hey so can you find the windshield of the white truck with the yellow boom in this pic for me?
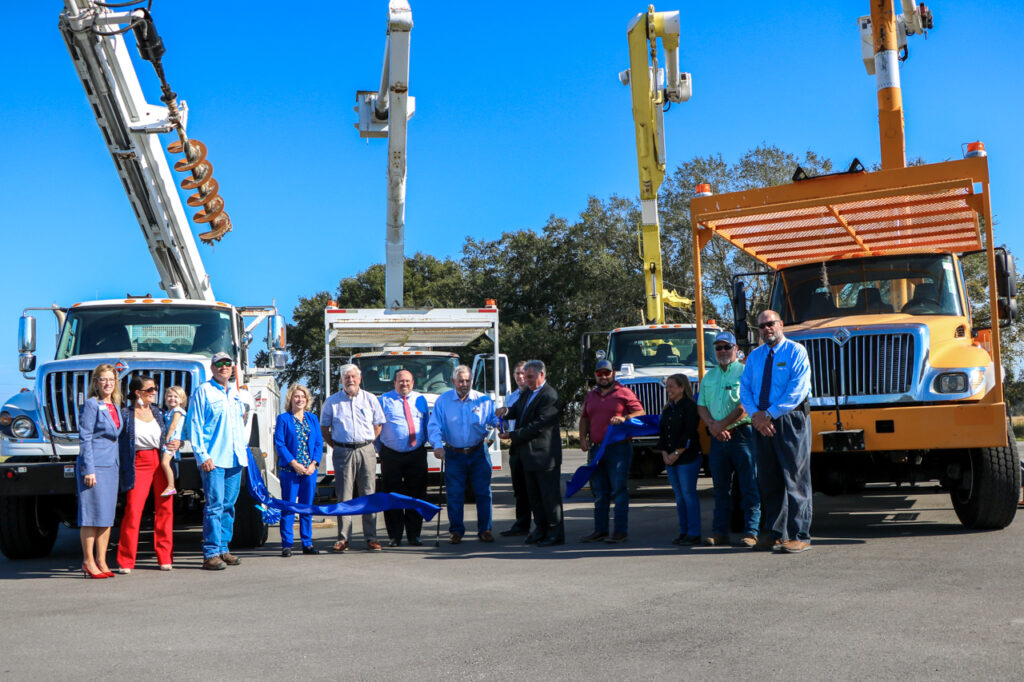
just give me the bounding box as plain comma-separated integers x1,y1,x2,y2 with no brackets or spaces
608,328,718,372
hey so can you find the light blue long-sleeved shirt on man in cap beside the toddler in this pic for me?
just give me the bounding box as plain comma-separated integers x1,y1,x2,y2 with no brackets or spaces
185,379,249,469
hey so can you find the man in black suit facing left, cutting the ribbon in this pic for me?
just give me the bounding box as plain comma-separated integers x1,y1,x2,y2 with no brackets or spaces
497,360,565,547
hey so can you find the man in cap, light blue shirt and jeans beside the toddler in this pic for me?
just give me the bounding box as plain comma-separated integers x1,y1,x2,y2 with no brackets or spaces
185,352,249,570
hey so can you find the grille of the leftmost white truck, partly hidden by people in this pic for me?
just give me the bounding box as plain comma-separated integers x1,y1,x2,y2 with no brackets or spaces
43,369,193,435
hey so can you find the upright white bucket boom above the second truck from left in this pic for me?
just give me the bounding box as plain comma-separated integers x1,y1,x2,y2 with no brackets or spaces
355,0,416,308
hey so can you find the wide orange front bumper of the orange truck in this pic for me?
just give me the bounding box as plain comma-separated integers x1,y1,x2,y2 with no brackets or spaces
811,402,1007,453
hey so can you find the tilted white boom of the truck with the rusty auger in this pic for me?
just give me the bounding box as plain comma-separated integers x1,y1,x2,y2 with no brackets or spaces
59,0,215,301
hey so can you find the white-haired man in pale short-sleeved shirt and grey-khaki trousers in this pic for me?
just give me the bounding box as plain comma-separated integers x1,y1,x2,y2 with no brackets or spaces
321,365,384,552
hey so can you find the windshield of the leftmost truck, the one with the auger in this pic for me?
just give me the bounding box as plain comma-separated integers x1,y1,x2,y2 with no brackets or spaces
56,305,233,359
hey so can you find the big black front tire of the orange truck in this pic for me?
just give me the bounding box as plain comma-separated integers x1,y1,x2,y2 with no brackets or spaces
949,421,1021,530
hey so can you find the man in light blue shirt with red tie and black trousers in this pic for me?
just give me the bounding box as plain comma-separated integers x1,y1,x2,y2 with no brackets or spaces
380,370,430,547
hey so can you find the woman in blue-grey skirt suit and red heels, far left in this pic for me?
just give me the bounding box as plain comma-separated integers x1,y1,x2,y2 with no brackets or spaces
75,365,124,578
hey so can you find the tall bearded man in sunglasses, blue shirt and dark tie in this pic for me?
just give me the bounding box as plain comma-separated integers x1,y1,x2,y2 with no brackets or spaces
739,310,812,553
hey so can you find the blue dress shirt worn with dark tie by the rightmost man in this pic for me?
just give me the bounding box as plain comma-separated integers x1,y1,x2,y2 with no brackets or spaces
739,337,811,419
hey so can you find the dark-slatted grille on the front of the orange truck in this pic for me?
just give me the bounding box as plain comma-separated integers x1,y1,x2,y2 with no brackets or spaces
794,334,913,397
